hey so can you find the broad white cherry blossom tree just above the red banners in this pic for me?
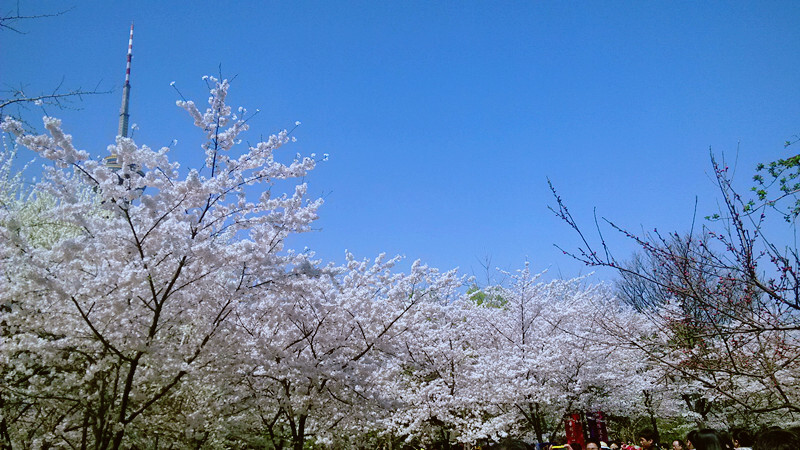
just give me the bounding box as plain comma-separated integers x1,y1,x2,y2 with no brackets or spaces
388,265,649,444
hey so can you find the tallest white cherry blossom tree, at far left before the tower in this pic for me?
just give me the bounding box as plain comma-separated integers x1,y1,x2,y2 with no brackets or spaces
0,78,321,448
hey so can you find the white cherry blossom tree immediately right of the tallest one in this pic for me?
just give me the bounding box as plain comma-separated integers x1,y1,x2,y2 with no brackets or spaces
231,255,460,450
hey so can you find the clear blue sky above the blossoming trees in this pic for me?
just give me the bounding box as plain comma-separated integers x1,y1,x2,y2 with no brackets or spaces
0,1,800,278
